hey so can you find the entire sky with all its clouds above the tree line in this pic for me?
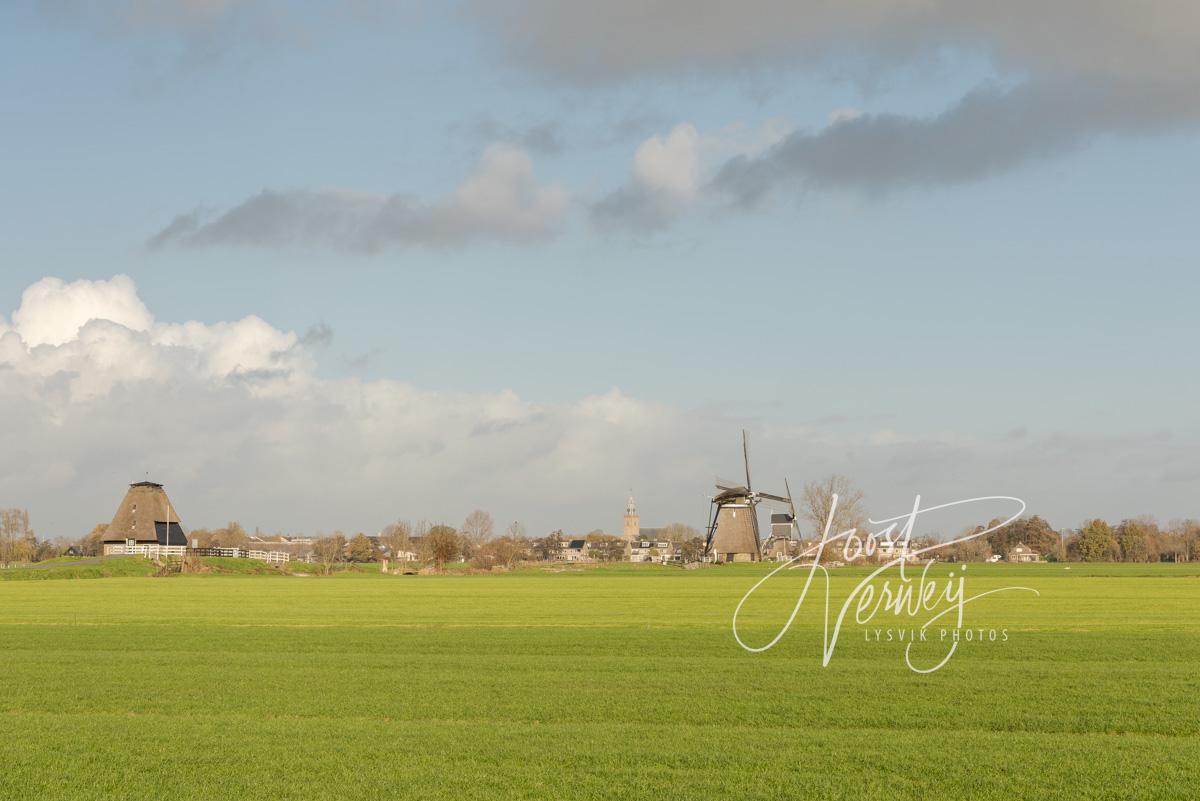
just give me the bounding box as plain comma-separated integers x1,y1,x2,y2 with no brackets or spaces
0,0,1200,537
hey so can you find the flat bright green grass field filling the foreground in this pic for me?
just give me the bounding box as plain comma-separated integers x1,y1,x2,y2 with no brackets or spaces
0,565,1200,801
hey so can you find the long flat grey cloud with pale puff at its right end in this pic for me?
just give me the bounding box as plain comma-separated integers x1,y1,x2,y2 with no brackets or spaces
149,144,570,252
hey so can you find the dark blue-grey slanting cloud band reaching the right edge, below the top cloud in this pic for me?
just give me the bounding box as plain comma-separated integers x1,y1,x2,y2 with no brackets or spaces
710,82,1200,204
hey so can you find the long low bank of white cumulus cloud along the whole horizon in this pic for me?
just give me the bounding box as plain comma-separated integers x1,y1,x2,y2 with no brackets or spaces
0,277,1200,536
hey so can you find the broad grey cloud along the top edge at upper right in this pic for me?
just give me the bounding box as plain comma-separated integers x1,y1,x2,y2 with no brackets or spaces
468,0,1200,88
